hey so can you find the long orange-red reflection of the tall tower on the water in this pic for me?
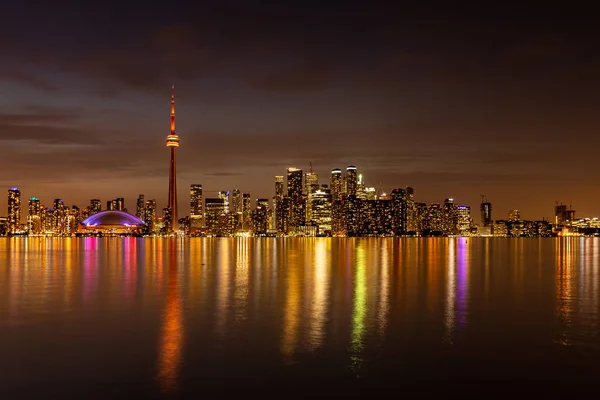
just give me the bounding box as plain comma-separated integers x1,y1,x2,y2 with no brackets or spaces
157,239,183,393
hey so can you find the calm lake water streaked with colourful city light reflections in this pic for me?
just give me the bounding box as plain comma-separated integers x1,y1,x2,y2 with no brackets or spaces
0,238,600,399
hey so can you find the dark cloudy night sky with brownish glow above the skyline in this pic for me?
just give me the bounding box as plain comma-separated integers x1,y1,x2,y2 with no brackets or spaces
0,0,600,220
